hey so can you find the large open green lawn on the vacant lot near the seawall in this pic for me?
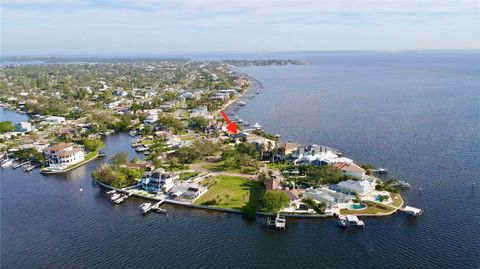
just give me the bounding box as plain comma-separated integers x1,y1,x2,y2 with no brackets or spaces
195,176,263,209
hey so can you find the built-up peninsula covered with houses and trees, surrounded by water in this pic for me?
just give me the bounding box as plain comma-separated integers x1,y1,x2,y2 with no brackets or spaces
0,59,416,218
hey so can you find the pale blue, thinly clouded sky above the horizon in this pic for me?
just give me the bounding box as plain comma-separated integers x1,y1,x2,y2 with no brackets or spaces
0,0,480,56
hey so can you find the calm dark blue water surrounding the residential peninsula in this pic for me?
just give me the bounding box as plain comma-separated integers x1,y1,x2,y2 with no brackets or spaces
0,52,480,268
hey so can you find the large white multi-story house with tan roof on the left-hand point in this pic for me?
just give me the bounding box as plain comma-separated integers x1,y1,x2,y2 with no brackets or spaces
44,143,85,170
